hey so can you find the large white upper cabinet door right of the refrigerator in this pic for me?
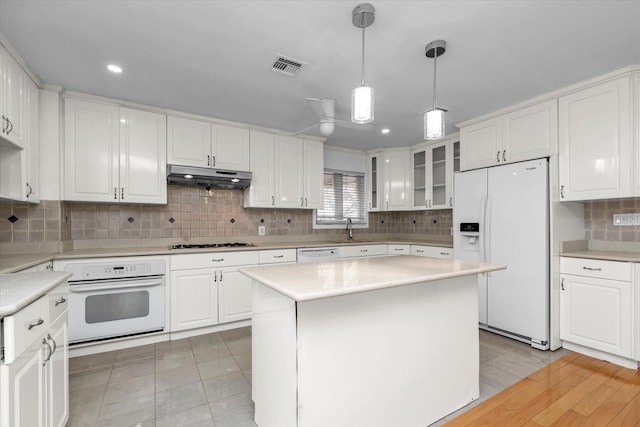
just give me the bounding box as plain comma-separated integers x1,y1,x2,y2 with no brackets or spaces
558,77,632,200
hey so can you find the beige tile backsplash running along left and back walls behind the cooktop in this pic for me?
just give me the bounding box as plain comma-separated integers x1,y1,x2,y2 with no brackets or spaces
0,185,452,246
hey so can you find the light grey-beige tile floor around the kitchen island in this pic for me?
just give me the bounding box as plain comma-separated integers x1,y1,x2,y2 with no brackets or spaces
68,327,567,427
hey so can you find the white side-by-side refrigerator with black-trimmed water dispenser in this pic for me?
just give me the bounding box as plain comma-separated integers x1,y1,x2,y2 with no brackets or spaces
453,159,549,350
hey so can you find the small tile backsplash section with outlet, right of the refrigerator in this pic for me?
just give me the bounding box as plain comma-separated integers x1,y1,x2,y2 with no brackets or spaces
584,198,640,242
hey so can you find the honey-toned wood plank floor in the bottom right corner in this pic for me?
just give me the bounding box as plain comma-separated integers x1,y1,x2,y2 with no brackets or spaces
445,353,640,427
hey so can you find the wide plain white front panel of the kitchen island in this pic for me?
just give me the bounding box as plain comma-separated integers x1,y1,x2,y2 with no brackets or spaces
296,275,480,427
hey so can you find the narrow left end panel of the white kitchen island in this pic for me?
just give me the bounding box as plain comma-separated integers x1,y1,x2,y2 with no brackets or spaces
251,280,297,427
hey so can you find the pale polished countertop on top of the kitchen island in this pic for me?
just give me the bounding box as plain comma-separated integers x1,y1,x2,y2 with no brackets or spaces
240,256,506,302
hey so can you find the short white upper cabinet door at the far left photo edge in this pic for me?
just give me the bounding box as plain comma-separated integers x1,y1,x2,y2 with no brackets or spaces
0,49,28,147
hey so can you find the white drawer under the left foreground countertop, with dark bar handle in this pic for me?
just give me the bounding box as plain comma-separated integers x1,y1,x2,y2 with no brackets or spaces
3,295,50,364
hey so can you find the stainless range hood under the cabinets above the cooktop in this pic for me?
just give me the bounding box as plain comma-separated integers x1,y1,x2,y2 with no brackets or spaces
167,165,251,190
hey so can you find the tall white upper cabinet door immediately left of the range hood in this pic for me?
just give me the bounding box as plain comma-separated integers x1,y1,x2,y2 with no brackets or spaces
120,108,167,204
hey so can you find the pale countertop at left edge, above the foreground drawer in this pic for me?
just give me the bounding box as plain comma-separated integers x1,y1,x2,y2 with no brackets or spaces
0,271,71,318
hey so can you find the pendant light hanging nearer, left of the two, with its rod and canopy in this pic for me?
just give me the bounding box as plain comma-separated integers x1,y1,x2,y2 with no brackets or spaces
351,3,376,124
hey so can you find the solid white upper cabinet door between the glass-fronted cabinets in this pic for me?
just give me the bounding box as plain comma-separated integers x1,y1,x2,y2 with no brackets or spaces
384,150,413,211
